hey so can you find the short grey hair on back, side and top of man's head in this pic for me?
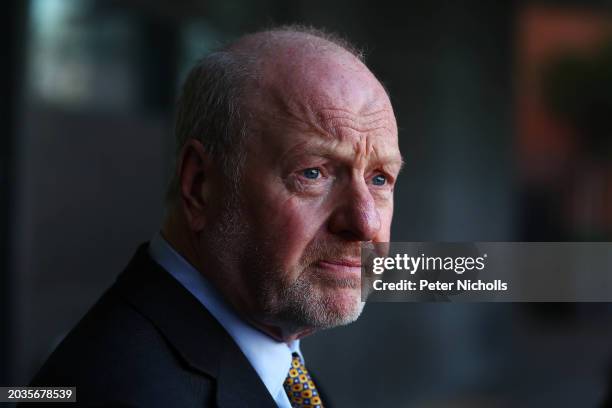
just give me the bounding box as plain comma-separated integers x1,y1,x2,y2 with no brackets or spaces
166,25,364,203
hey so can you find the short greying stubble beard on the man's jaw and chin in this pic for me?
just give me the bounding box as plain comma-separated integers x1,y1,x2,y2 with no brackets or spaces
211,188,365,333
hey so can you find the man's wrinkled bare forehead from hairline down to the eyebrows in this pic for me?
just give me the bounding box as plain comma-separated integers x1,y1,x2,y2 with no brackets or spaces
244,49,401,169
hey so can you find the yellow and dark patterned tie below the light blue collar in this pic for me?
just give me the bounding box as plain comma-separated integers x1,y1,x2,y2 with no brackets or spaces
283,353,323,408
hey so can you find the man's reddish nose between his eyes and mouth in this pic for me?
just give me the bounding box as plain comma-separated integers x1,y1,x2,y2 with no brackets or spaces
329,180,381,241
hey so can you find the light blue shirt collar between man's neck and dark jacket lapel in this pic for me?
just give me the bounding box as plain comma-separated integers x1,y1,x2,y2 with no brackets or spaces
149,232,304,406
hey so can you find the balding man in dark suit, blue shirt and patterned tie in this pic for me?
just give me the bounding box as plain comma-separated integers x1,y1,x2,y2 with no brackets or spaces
26,27,402,407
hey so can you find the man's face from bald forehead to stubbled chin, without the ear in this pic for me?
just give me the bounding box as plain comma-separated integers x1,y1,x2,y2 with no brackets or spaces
208,49,401,331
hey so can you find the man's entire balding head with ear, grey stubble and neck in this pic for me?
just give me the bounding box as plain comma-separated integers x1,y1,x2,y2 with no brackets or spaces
164,28,402,341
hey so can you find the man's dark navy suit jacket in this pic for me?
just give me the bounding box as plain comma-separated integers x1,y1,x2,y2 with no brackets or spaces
24,244,276,408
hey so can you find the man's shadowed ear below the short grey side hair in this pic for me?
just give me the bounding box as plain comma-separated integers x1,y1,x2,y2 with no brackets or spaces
177,139,212,232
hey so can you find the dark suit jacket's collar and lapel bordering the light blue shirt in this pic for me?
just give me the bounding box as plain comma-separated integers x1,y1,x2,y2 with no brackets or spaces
115,243,276,408
